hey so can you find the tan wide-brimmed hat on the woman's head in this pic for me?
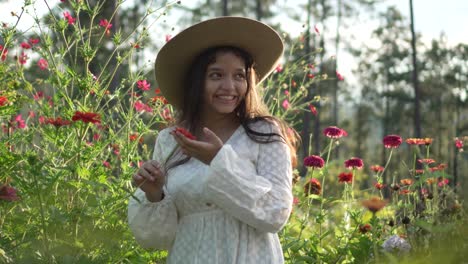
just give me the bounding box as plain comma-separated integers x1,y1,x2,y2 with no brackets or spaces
155,17,284,108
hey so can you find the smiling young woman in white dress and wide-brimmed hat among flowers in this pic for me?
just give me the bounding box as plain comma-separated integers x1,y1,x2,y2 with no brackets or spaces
128,17,295,264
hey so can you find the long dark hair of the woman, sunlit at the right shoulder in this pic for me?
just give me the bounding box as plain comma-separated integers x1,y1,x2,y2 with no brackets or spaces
165,46,299,171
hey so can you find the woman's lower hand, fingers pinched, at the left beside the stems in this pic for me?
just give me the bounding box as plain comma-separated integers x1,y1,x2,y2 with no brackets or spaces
133,160,166,202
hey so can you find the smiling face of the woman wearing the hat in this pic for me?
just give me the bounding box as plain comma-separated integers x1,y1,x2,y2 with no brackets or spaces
203,52,247,118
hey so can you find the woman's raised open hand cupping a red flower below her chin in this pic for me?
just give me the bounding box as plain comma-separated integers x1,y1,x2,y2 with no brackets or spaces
171,127,223,165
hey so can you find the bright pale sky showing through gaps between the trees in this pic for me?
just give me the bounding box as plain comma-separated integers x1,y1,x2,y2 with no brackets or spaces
0,0,468,84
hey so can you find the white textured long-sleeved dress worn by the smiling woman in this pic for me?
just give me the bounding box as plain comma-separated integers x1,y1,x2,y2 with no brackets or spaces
128,121,293,264
